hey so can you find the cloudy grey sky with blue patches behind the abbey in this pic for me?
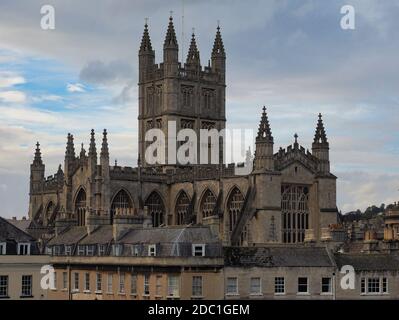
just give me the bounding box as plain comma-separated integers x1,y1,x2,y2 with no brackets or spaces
0,0,399,217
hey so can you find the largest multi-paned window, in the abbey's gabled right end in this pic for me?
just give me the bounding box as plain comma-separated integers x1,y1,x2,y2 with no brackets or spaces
281,185,309,243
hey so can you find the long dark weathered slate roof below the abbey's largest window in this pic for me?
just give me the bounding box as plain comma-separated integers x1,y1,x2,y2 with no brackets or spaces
224,247,335,267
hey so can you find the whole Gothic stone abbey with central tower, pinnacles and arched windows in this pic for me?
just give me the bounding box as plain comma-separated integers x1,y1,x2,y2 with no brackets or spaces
29,18,338,247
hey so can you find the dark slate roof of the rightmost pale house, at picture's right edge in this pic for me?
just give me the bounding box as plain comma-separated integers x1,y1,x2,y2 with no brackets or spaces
334,253,399,271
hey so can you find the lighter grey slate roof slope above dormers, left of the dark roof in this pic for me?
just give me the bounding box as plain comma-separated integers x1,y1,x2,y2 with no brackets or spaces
118,227,218,243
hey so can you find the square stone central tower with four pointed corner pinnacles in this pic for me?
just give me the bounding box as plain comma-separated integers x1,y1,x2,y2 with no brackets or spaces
138,17,226,166
